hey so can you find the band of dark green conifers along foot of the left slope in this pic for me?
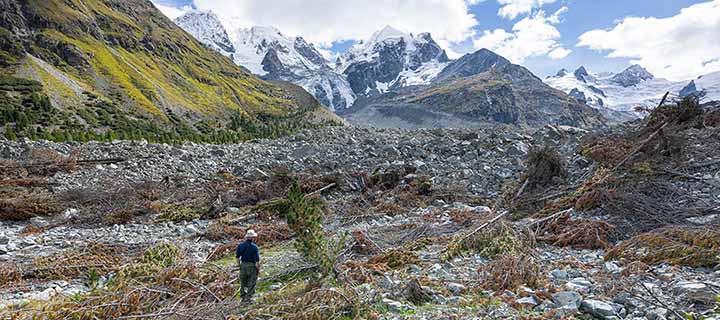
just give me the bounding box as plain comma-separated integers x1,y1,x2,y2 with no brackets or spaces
0,75,340,144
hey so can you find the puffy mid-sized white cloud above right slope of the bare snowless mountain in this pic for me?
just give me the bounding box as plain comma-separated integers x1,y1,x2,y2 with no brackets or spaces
473,7,572,63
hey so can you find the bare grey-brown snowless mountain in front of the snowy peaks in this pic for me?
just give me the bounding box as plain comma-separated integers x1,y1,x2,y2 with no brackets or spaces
340,49,605,128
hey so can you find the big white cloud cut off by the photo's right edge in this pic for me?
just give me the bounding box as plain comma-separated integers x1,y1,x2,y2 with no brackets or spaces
578,0,720,80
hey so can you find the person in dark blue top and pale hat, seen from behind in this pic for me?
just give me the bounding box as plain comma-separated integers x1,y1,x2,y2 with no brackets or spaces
235,229,260,302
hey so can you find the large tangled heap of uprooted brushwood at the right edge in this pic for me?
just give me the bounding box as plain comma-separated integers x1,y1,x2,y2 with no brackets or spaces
506,97,720,249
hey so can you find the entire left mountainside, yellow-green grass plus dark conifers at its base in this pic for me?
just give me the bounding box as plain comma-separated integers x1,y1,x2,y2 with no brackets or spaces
0,0,336,142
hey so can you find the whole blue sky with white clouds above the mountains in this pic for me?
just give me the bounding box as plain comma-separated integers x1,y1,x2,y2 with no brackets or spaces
152,0,720,81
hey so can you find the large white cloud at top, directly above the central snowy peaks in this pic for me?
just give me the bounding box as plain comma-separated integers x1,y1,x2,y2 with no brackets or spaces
188,0,479,48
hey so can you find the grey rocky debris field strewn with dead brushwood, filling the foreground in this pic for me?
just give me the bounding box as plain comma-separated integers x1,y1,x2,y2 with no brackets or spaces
0,99,720,319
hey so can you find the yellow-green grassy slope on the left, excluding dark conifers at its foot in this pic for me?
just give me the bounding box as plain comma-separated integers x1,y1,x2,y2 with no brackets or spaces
0,0,340,142
